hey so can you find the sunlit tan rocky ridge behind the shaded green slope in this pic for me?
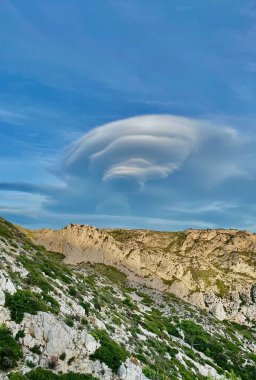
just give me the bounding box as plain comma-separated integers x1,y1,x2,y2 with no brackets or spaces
28,224,256,324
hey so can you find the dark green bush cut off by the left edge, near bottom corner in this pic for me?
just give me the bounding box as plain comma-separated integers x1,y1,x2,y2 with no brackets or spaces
0,325,23,370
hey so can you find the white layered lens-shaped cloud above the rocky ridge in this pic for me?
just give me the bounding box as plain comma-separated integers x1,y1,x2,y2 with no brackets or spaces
63,115,240,185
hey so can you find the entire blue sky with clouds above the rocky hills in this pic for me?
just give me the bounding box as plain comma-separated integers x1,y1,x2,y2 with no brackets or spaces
0,0,256,232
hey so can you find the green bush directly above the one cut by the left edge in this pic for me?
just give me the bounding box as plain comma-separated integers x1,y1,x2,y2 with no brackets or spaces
5,290,47,323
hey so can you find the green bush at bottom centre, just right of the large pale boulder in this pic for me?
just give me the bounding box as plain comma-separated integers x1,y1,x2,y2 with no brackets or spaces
90,330,128,373
